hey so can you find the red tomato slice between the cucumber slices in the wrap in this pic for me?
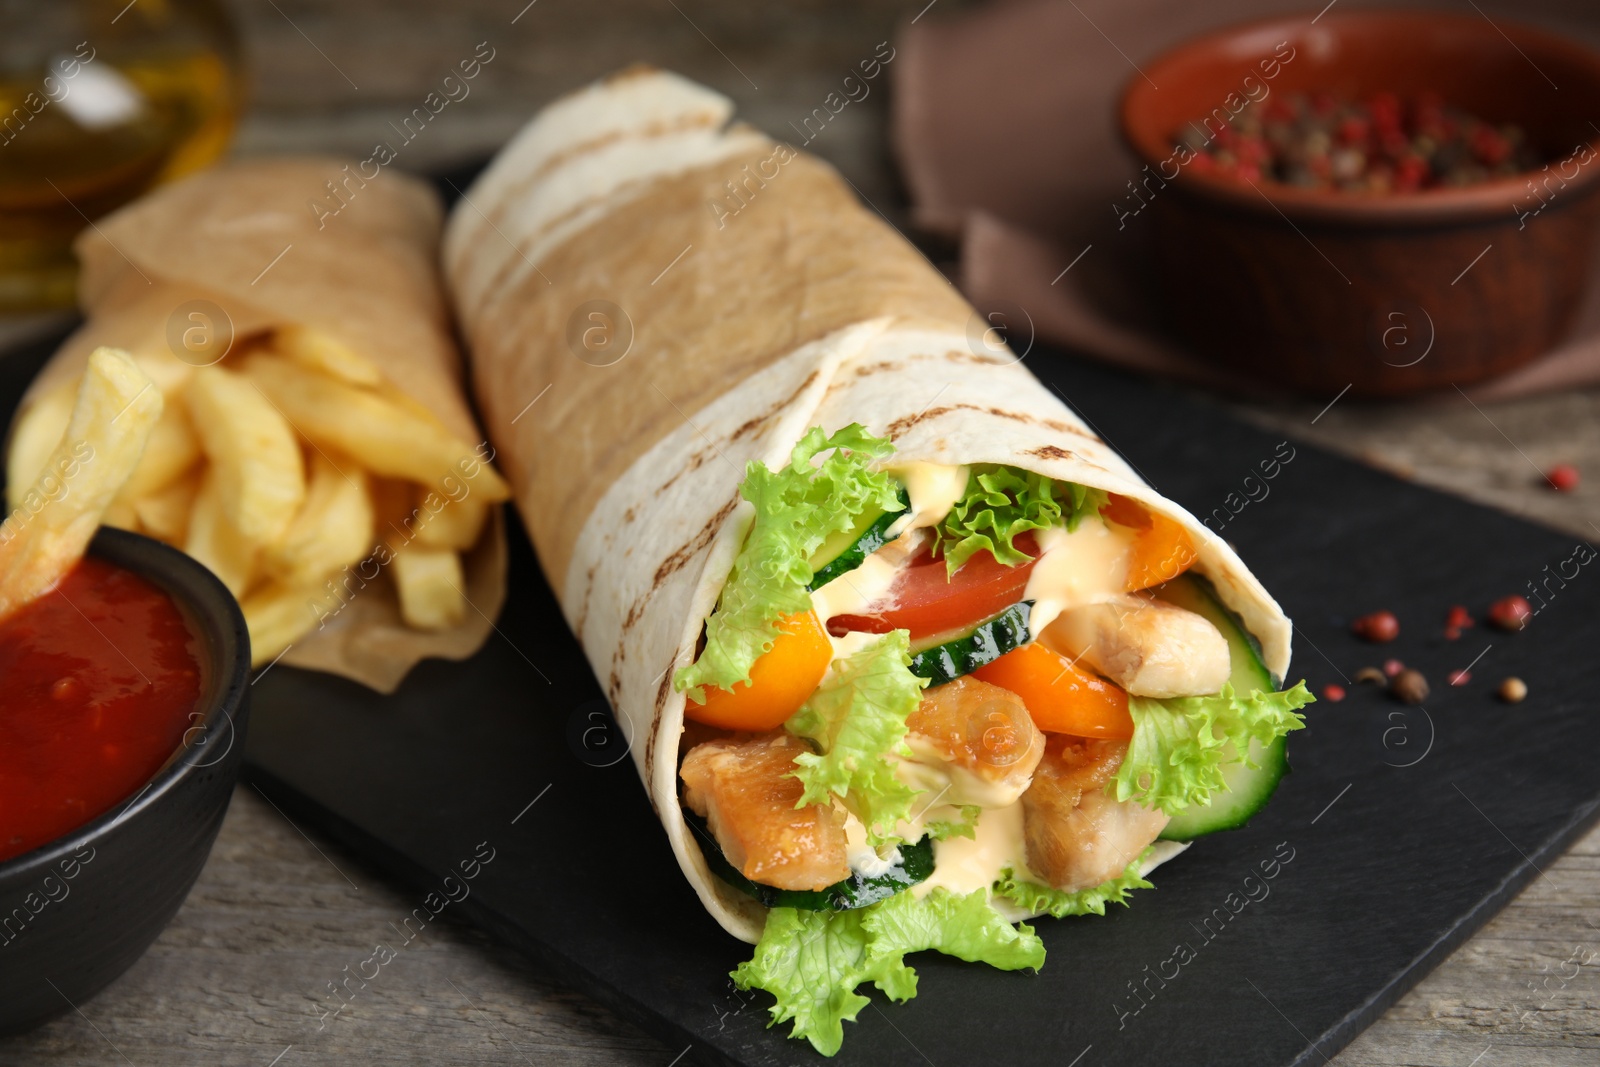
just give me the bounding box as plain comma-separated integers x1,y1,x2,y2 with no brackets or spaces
827,533,1038,643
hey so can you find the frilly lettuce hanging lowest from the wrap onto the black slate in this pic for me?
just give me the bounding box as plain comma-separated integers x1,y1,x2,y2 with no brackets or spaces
733,889,1045,1056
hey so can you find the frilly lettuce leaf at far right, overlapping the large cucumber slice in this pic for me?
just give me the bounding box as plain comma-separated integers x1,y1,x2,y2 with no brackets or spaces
1112,681,1315,814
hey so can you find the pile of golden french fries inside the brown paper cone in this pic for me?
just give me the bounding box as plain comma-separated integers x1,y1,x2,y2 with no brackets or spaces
6,326,510,665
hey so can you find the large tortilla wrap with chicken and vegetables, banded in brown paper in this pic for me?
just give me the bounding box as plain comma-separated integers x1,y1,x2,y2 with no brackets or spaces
445,69,1310,1054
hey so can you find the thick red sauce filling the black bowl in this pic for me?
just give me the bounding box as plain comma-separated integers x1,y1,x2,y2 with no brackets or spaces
0,558,200,859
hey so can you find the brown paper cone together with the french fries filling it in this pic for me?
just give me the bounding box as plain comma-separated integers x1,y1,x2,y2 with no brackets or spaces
6,158,507,693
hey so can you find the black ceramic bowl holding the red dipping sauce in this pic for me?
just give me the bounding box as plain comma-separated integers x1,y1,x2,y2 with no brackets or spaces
0,528,250,1033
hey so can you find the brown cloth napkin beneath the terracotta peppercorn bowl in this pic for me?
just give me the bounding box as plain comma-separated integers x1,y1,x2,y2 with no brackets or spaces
893,0,1600,400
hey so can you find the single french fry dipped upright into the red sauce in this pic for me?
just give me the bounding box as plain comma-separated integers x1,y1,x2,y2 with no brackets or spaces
0,347,162,617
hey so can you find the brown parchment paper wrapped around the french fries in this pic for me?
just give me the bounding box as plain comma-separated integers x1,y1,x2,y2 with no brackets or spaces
19,158,506,693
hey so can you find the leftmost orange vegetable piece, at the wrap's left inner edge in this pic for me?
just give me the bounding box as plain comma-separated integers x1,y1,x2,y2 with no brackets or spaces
683,611,834,731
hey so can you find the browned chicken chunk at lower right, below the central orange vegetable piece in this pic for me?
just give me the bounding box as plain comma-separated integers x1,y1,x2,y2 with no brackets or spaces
1022,734,1166,893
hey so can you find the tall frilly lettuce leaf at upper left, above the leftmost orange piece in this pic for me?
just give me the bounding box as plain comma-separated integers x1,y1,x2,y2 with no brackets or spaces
672,422,902,701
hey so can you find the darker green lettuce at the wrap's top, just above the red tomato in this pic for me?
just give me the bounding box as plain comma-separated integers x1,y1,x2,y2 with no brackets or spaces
934,466,1106,574
